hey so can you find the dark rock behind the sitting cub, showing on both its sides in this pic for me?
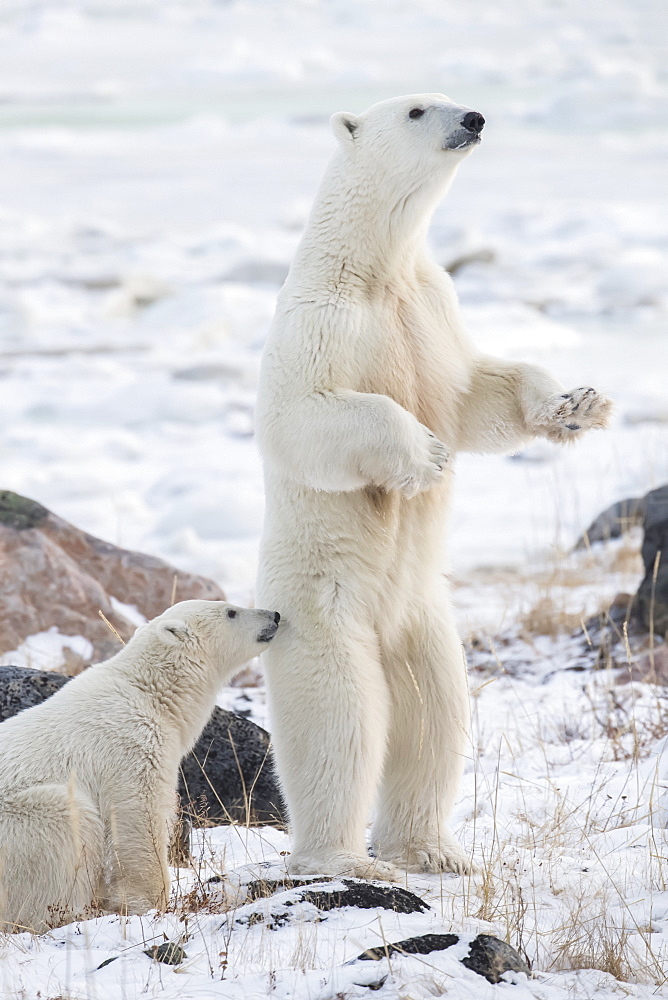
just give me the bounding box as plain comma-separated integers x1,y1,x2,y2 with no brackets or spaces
0,667,285,828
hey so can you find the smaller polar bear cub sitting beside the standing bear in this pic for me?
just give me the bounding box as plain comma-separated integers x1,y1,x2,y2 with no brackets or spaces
0,601,280,933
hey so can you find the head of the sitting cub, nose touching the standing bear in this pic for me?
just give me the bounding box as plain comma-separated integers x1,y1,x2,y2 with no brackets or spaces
137,601,281,675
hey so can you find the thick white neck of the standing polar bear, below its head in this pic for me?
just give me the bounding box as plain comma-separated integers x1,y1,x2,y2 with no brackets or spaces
295,155,454,284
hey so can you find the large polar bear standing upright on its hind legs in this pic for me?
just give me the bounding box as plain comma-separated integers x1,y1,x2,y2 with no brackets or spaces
257,94,610,878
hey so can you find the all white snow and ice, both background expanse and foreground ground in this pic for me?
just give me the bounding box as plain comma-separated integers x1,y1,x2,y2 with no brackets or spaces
0,0,668,1000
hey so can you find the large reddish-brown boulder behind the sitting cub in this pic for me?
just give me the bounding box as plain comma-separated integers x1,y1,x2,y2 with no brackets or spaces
0,490,225,672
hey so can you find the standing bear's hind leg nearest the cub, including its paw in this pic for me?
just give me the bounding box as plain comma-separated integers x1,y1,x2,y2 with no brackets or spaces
265,609,397,880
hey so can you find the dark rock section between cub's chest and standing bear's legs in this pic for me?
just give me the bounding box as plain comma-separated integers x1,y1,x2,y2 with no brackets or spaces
179,707,286,828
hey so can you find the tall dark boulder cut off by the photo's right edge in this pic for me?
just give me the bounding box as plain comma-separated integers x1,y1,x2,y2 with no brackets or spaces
633,486,668,636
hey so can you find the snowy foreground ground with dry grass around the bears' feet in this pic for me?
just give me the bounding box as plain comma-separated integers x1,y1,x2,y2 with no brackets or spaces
0,592,668,1000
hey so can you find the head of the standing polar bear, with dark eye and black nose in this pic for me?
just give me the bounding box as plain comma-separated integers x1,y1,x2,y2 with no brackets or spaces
331,94,485,183
